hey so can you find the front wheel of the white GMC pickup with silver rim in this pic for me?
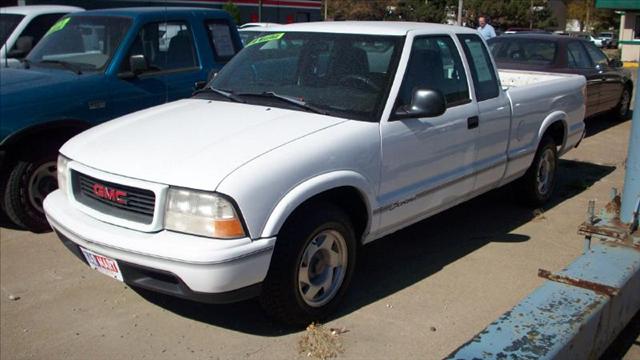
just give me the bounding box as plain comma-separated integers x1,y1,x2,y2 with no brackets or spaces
260,203,356,326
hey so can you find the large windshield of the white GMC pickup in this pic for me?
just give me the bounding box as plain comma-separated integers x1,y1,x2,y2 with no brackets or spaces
211,32,404,121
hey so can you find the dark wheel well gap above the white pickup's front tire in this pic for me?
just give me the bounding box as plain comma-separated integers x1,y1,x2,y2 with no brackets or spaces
289,186,369,240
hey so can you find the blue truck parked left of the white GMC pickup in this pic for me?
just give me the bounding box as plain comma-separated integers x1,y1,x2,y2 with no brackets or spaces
0,7,242,232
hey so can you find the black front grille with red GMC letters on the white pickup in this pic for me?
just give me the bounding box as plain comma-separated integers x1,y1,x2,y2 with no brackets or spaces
71,170,156,224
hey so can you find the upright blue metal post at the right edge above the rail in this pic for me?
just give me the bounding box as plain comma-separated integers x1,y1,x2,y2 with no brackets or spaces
620,69,640,226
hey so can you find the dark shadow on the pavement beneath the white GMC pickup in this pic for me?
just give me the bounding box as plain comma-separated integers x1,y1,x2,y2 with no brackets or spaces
136,160,615,336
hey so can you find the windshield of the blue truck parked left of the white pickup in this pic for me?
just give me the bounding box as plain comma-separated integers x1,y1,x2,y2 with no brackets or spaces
27,16,131,70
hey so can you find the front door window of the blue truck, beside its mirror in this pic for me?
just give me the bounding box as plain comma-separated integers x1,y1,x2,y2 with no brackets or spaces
120,21,198,72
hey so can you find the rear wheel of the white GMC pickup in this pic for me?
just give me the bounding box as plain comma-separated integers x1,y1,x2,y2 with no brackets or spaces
515,135,558,207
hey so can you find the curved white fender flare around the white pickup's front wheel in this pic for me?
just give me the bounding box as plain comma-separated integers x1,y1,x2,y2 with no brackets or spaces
260,170,375,238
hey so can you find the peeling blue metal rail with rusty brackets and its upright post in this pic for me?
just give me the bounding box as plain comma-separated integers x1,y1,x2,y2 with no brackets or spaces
448,70,640,359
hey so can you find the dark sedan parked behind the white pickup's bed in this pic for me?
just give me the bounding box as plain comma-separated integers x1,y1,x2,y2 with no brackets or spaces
487,34,633,120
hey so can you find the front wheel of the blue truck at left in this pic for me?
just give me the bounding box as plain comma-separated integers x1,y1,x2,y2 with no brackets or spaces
3,155,58,233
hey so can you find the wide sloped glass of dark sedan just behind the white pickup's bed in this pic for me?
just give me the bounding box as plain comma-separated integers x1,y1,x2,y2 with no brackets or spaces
488,38,558,65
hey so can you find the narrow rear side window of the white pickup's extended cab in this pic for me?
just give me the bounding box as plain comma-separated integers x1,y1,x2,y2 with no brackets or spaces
458,34,500,101
